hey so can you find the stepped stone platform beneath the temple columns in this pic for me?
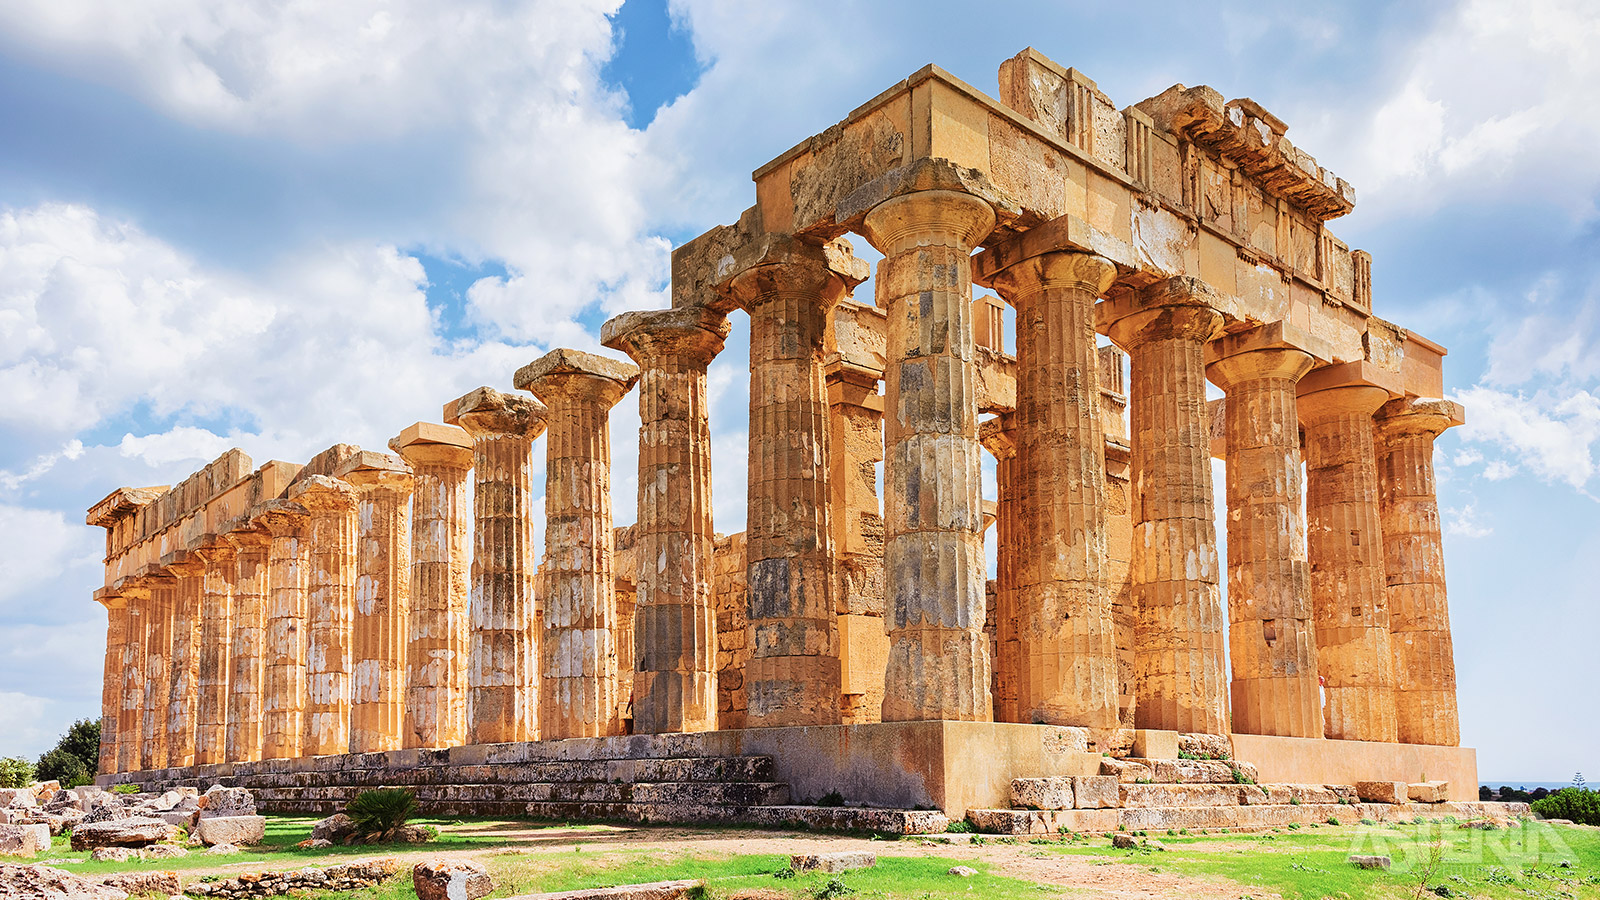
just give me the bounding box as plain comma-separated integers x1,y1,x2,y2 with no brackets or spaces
99,721,1477,833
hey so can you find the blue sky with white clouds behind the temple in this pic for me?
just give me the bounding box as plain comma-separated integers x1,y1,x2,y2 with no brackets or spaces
0,0,1600,780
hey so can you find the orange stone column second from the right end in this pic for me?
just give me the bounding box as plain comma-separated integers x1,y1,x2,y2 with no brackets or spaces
1299,364,1397,741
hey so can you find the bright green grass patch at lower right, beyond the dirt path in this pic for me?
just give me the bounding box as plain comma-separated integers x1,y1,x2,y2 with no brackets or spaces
1053,823,1600,900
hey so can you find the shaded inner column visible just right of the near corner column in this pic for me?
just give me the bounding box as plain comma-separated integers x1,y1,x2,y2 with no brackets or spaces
978,413,1032,722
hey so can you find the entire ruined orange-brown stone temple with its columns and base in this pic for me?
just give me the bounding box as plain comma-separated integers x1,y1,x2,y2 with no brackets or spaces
88,50,1510,831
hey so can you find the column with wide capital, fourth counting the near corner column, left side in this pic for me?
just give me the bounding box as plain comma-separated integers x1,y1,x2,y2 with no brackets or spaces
515,349,638,740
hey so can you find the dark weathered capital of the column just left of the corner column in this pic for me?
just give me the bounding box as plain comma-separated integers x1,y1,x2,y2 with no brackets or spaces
717,234,870,309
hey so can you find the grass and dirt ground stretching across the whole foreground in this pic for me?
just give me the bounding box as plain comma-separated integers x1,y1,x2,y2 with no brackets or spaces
34,817,1600,900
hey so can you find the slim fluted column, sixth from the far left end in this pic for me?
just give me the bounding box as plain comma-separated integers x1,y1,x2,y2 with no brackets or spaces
224,528,272,762
